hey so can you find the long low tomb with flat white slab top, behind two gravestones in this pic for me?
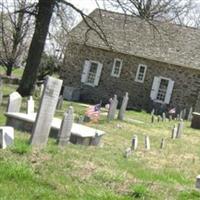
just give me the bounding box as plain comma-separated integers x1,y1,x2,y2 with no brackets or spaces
5,112,105,145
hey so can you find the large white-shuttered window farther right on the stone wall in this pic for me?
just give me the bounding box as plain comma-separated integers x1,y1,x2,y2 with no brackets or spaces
150,76,174,104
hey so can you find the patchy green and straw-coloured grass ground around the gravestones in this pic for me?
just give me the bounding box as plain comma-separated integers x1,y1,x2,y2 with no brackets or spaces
0,84,200,200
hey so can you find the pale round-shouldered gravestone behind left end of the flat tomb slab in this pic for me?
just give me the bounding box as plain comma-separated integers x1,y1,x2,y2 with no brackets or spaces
7,92,22,112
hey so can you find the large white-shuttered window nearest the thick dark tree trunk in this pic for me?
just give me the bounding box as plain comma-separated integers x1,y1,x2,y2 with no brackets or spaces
81,60,103,87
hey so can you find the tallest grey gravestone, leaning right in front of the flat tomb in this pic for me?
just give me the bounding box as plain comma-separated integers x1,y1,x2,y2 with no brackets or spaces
30,76,62,146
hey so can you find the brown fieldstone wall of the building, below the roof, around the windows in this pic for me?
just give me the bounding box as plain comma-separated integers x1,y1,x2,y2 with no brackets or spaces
60,43,200,110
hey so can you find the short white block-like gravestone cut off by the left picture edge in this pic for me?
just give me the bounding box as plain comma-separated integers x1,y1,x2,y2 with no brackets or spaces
0,126,14,149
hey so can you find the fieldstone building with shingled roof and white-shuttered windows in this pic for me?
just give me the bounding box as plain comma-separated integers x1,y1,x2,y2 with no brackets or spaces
60,9,200,110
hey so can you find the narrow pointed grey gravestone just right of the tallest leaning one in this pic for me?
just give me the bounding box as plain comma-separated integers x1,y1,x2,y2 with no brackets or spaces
58,106,74,146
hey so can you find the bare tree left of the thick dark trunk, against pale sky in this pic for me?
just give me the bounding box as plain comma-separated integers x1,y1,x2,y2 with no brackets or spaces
0,0,34,76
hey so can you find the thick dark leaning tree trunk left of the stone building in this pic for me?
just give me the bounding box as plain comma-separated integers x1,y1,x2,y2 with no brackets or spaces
17,0,55,96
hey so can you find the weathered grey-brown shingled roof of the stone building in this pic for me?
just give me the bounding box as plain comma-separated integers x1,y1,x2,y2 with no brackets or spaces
71,9,200,69
